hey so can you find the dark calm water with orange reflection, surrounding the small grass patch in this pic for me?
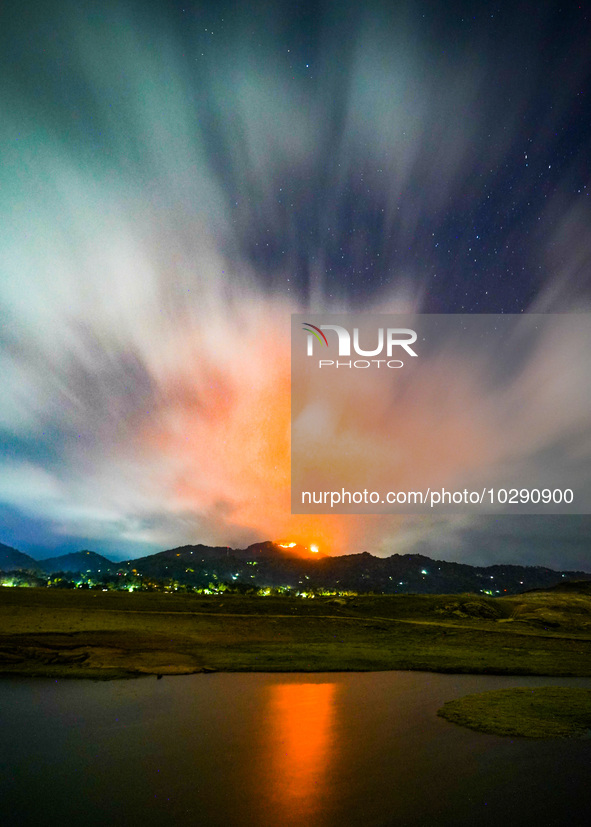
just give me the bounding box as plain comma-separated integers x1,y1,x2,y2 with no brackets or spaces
0,672,591,827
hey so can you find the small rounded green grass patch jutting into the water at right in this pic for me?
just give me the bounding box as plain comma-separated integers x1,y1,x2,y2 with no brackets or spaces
437,686,591,738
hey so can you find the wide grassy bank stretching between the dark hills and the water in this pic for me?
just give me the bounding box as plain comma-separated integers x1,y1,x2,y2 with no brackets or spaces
0,588,591,678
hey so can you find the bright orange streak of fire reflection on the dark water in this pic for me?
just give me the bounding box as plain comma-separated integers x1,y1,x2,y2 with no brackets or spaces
268,683,337,823
